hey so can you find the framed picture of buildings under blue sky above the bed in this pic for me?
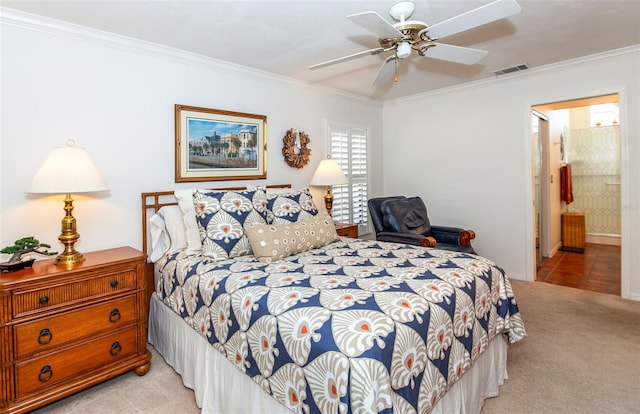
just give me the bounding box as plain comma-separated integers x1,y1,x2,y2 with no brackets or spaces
175,105,267,183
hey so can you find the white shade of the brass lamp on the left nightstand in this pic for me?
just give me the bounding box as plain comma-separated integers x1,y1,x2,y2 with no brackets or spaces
27,140,109,194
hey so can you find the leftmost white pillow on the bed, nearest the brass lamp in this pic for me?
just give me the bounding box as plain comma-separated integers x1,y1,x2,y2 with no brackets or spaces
149,206,187,262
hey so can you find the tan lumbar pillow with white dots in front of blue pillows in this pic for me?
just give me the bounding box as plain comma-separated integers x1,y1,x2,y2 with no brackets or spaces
245,213,340,263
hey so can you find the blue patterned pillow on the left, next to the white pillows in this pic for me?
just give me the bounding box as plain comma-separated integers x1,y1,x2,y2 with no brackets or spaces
193,188,267,259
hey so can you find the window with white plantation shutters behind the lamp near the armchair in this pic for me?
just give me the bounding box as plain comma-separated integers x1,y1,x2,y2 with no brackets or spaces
328,124,369,232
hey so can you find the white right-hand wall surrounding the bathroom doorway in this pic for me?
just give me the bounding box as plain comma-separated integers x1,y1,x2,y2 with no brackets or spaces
383,47,640,300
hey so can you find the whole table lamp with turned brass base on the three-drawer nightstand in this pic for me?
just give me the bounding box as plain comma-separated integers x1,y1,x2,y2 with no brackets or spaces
26,139,109,265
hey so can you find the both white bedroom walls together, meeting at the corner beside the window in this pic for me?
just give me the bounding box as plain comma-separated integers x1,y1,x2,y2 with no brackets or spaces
0,10,640,300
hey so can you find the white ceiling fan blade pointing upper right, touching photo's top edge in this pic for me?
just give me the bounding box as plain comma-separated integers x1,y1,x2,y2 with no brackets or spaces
428,0,522,39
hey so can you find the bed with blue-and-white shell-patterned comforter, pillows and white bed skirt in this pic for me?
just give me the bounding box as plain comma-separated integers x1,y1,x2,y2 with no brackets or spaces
142,185,526,413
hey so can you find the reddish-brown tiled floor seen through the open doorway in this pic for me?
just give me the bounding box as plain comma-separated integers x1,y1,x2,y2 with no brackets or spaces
536,243,620,295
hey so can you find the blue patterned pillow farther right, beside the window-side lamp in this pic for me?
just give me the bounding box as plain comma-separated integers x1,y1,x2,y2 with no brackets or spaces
267,188,318,224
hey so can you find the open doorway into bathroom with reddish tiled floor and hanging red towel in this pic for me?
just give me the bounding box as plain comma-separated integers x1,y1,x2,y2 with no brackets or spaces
532,94,622,295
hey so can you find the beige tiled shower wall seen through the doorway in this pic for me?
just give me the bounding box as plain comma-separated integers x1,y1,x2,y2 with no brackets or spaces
567,125,620,235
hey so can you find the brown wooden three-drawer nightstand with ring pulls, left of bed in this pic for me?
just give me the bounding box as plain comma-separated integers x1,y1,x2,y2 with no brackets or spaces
0,247,151,414
